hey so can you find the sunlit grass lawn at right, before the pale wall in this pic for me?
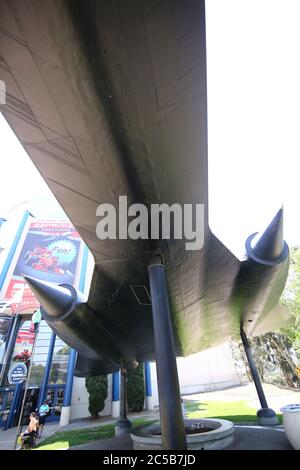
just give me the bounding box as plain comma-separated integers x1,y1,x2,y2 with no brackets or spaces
184,400,282,423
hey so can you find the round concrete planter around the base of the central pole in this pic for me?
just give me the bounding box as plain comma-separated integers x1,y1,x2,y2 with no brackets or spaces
131,419,234,450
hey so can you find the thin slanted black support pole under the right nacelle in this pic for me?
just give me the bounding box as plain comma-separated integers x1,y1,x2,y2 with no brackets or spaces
241,328,277,425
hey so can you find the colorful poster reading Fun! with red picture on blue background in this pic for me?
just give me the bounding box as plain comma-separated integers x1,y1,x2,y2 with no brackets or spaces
13,222,80,285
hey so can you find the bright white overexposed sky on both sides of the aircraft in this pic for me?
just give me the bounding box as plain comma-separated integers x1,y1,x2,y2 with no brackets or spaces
0,0,300,256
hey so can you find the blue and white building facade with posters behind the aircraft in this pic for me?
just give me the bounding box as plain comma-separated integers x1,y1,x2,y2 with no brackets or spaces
0,212,243,429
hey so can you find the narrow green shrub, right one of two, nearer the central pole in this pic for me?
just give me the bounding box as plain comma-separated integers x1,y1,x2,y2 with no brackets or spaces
127,363,145,411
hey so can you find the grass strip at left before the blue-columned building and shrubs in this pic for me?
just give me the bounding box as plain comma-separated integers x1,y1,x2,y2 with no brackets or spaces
33,418,153,450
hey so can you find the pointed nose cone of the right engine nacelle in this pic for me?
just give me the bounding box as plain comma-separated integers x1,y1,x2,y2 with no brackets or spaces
246,208,288,264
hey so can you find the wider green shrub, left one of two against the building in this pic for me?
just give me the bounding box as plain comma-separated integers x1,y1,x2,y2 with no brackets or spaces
85,375,107,419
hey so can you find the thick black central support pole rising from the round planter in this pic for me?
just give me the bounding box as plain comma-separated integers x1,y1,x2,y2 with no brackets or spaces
148,262,187,450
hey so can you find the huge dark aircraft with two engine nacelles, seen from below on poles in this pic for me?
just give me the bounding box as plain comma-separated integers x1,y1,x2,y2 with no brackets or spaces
0,0,289,448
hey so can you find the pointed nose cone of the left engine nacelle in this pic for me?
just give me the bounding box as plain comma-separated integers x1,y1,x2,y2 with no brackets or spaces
24,276,77,319
